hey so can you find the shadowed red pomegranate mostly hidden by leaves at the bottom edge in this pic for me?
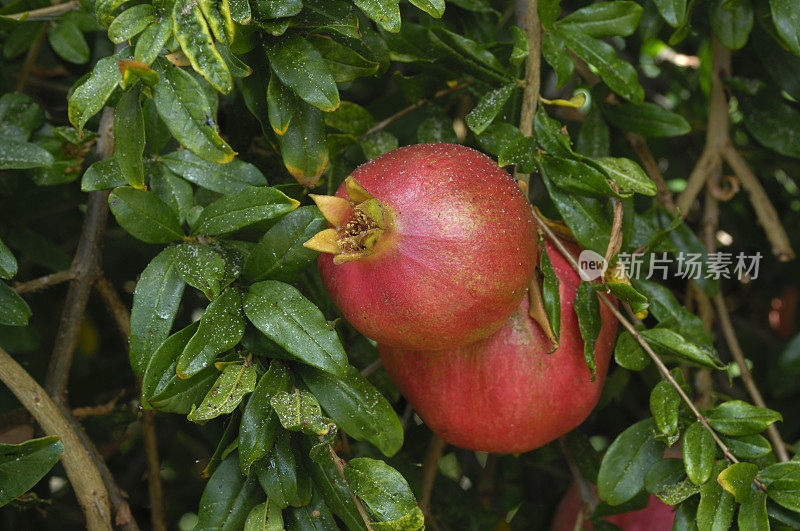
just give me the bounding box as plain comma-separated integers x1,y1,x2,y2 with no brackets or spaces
550,485,675,531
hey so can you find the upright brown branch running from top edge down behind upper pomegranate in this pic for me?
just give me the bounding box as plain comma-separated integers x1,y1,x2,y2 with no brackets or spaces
514,0,542,189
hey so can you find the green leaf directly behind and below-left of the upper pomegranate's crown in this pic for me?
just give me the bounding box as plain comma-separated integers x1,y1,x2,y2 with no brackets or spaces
242,206,328,283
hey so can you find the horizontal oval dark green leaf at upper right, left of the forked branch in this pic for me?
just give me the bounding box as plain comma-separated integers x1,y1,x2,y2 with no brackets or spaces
602,102,691,138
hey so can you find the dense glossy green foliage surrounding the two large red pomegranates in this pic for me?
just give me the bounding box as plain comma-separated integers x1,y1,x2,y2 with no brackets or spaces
0,0,800,530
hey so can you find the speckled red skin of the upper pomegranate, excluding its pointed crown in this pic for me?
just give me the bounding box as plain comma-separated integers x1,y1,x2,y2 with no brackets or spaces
319,144,538,350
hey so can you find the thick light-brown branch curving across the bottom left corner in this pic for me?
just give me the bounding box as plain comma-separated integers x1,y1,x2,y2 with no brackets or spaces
0,347,111,530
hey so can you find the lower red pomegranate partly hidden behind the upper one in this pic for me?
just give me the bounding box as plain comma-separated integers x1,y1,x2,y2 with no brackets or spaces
378,242,617,453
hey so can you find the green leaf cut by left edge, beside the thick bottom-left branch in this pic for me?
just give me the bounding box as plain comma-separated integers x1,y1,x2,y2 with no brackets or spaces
0,436,64,507
